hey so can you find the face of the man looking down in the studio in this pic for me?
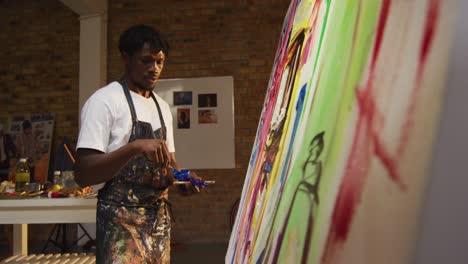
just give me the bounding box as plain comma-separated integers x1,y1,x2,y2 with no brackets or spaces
124,43,166,91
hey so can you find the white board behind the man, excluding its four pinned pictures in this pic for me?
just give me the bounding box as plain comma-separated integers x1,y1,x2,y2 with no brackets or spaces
155,76,236,169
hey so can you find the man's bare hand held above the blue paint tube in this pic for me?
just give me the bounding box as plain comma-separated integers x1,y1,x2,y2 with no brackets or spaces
131,139,171,167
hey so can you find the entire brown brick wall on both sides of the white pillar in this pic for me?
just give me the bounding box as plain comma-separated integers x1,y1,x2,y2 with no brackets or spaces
0,0,290,245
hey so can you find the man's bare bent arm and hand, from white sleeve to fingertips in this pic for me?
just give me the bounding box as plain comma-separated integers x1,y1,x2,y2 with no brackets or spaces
75,139,170,187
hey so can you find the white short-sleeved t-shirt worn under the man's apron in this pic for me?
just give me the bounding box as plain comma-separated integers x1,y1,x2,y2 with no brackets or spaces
76,82,175,153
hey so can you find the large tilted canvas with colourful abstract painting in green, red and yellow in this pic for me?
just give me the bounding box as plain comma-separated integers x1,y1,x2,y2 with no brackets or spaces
226,0,456,263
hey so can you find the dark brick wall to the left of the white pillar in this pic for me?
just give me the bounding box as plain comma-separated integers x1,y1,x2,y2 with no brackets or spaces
0,0,79,246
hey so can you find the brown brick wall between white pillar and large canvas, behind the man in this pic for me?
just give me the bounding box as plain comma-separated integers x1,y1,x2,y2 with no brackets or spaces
108,0,290,242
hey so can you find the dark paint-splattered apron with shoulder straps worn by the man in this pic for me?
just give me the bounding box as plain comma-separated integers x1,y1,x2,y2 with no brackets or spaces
96,81,172,263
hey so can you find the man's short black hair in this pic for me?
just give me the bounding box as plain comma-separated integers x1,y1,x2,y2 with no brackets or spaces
119,25,169,57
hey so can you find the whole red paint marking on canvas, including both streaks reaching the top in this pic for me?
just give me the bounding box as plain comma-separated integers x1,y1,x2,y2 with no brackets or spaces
322,0,440,263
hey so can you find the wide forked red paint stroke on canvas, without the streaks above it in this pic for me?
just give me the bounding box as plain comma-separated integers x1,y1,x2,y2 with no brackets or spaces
329,74,405,252
